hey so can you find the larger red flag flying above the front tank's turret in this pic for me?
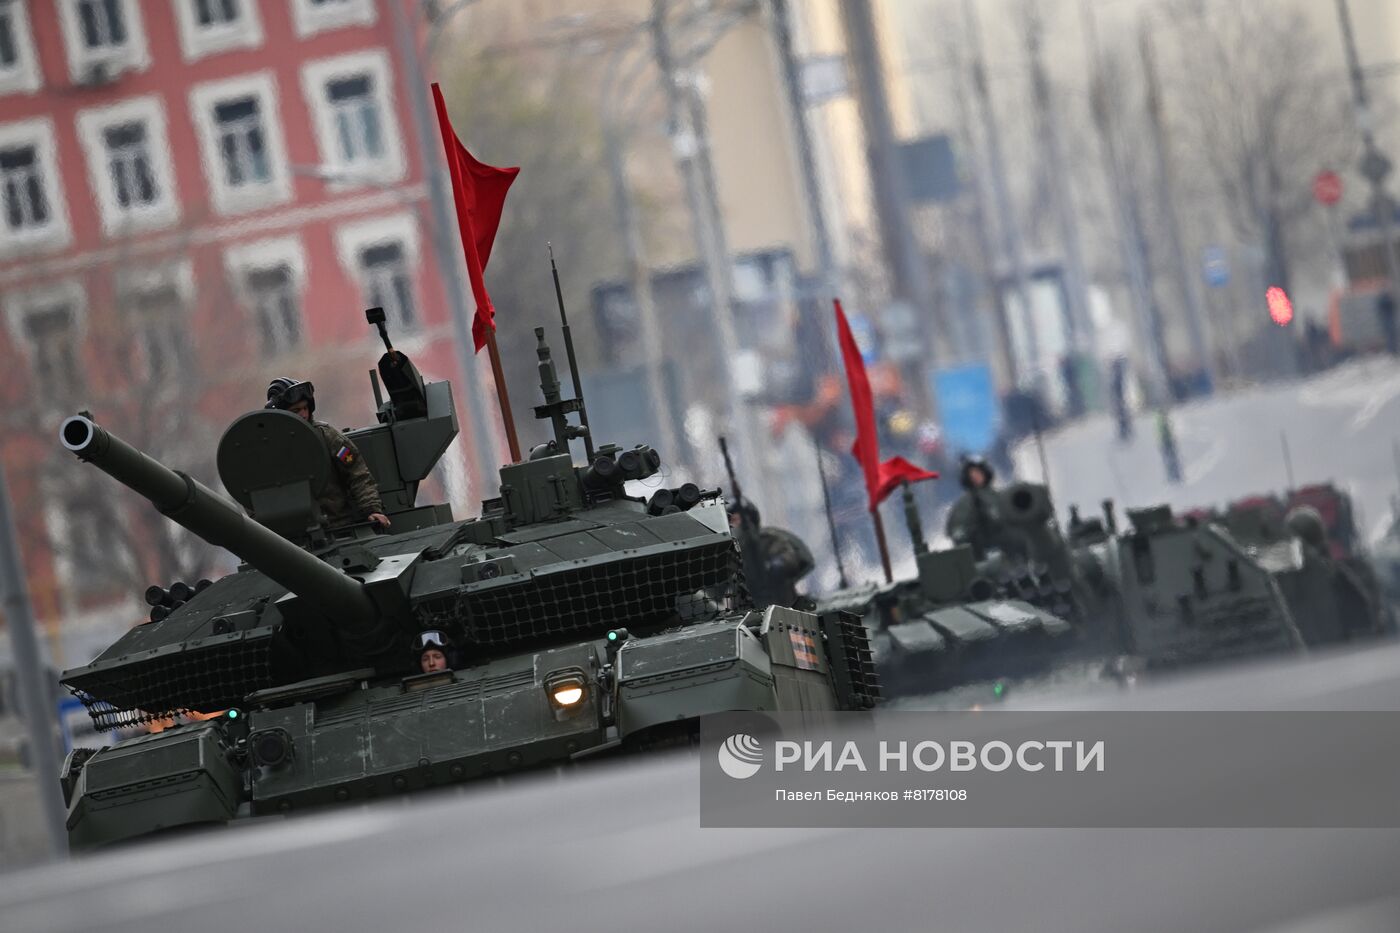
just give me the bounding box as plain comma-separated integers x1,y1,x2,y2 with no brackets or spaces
433,83,521,352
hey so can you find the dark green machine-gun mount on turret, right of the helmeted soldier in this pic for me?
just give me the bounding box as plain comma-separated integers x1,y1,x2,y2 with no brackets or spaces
346,308,458,534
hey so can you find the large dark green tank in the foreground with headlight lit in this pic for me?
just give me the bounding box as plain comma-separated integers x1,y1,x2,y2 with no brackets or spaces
60,315,879,849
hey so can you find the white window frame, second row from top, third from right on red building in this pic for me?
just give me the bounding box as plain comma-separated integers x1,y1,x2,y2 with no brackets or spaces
77,94,179,237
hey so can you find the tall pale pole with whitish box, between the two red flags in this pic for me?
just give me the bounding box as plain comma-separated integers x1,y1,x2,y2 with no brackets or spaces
650,0,764,487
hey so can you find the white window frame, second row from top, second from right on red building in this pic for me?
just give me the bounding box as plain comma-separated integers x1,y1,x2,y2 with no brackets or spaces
189,70,291,214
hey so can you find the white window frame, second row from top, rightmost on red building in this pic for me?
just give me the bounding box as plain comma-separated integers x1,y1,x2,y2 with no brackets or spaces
301,49,407,191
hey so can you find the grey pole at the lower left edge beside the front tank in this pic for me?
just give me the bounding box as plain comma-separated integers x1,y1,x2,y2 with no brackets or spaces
0,462,69,859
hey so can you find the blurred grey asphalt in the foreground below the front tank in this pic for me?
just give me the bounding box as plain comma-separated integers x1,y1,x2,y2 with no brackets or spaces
8,646,1400,933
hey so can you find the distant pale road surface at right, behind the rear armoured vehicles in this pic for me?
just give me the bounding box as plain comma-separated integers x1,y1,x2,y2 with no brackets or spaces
1015,357,1400,541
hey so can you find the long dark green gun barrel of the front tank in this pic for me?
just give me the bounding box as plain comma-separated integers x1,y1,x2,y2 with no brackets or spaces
59,415,378,629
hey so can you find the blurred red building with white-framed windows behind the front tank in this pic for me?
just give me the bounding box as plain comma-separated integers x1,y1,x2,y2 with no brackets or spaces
0,0,472,660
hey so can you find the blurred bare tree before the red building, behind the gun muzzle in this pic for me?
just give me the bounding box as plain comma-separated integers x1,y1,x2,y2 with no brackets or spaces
0,218,267,612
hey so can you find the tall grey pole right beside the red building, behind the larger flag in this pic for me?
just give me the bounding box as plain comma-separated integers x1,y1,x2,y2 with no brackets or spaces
388,0,504,499
